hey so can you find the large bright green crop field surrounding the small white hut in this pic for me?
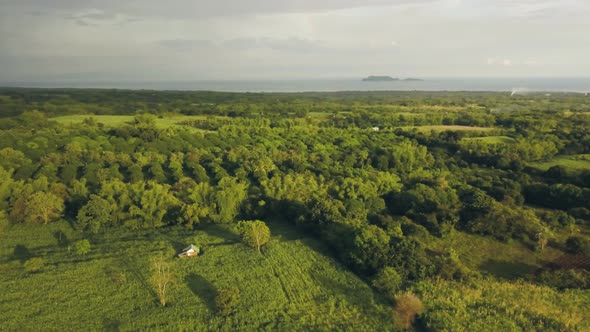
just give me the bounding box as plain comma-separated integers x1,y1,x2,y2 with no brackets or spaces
0,222,391,331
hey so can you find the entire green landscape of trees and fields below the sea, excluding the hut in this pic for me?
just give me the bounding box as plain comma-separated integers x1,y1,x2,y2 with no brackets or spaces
0,88,590,331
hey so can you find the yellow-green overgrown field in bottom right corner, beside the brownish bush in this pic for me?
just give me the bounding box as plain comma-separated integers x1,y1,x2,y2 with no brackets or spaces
415,279,590,331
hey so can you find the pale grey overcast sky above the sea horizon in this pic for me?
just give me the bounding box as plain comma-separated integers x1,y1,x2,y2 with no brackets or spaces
0,0,590,81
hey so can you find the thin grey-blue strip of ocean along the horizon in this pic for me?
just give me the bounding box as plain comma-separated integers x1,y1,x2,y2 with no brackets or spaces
0,77,590,93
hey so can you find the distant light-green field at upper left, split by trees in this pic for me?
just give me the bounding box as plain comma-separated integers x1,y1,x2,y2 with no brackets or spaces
51,115,213,129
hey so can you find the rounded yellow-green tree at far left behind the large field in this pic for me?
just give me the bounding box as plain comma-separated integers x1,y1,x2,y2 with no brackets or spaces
24,192,64,224
